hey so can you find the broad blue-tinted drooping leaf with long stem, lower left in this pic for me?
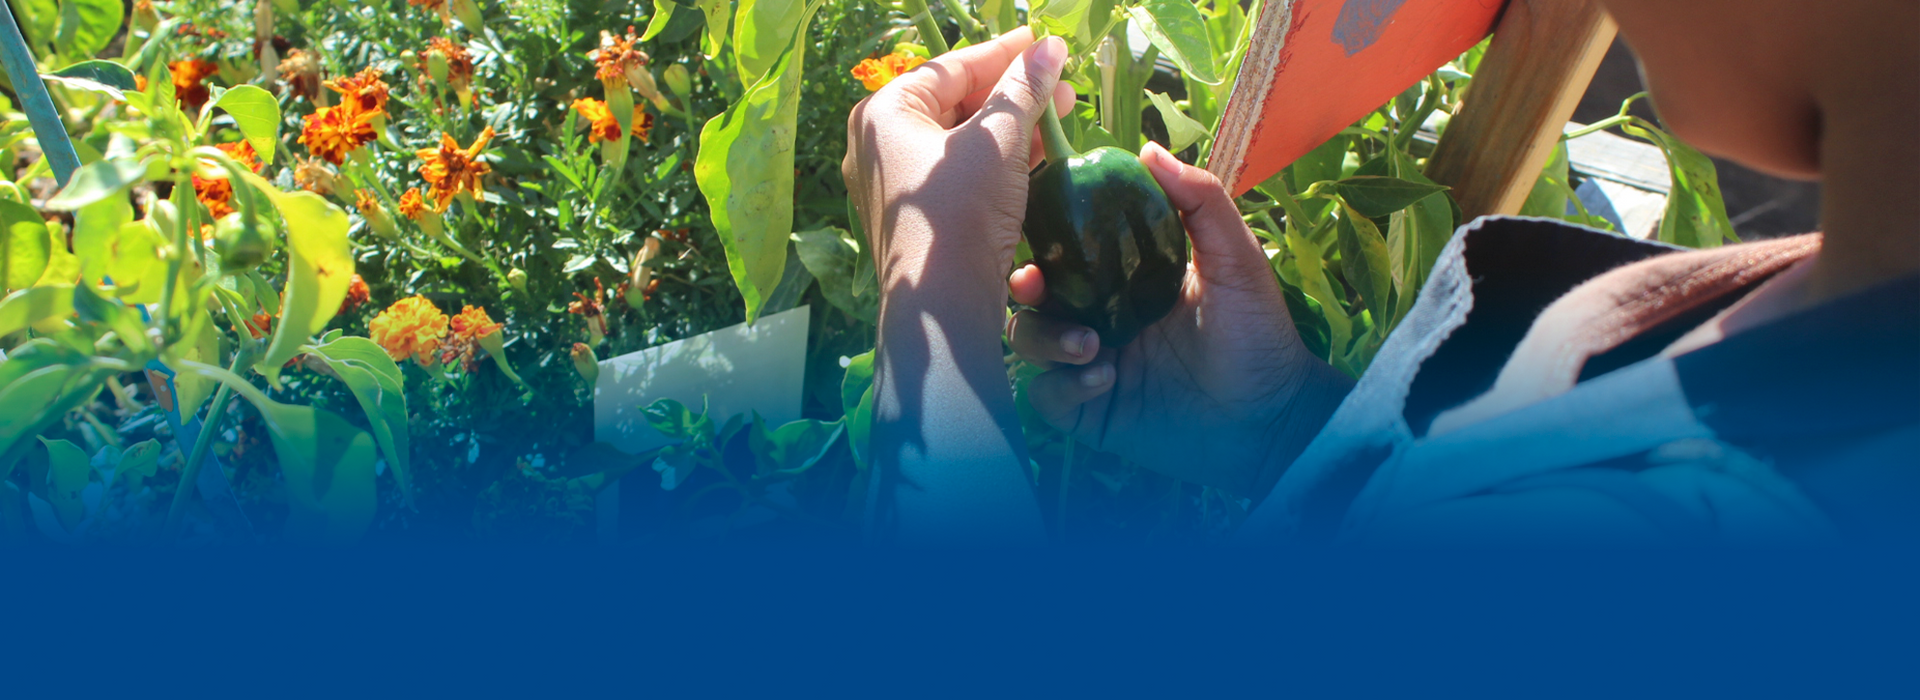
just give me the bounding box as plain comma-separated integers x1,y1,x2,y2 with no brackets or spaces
180,362,378,545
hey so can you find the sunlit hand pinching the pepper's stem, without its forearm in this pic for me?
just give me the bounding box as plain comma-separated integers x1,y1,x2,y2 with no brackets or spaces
841,27,1073,295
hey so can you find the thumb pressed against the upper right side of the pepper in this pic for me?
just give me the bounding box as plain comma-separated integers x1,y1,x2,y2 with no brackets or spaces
1140,142,1267,274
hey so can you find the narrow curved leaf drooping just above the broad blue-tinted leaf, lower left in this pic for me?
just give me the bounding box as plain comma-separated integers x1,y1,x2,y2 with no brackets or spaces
301,336,413,501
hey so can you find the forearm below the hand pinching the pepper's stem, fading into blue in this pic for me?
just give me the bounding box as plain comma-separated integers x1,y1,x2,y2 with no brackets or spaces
874,222,1044,543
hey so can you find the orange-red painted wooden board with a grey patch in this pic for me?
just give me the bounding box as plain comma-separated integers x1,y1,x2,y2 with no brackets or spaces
1208,0,1505,196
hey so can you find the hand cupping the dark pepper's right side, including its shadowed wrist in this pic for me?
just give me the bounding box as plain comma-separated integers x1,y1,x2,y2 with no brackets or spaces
1006,144,1352,497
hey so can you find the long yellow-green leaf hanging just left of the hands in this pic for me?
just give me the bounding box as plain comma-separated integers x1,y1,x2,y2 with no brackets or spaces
693,0,822,322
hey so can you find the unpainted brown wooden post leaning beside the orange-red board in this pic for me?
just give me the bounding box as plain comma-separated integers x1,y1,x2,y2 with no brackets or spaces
1427,0,1615,221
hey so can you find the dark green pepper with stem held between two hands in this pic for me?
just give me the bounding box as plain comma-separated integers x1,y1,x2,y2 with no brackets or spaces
1021,104,1187,349
